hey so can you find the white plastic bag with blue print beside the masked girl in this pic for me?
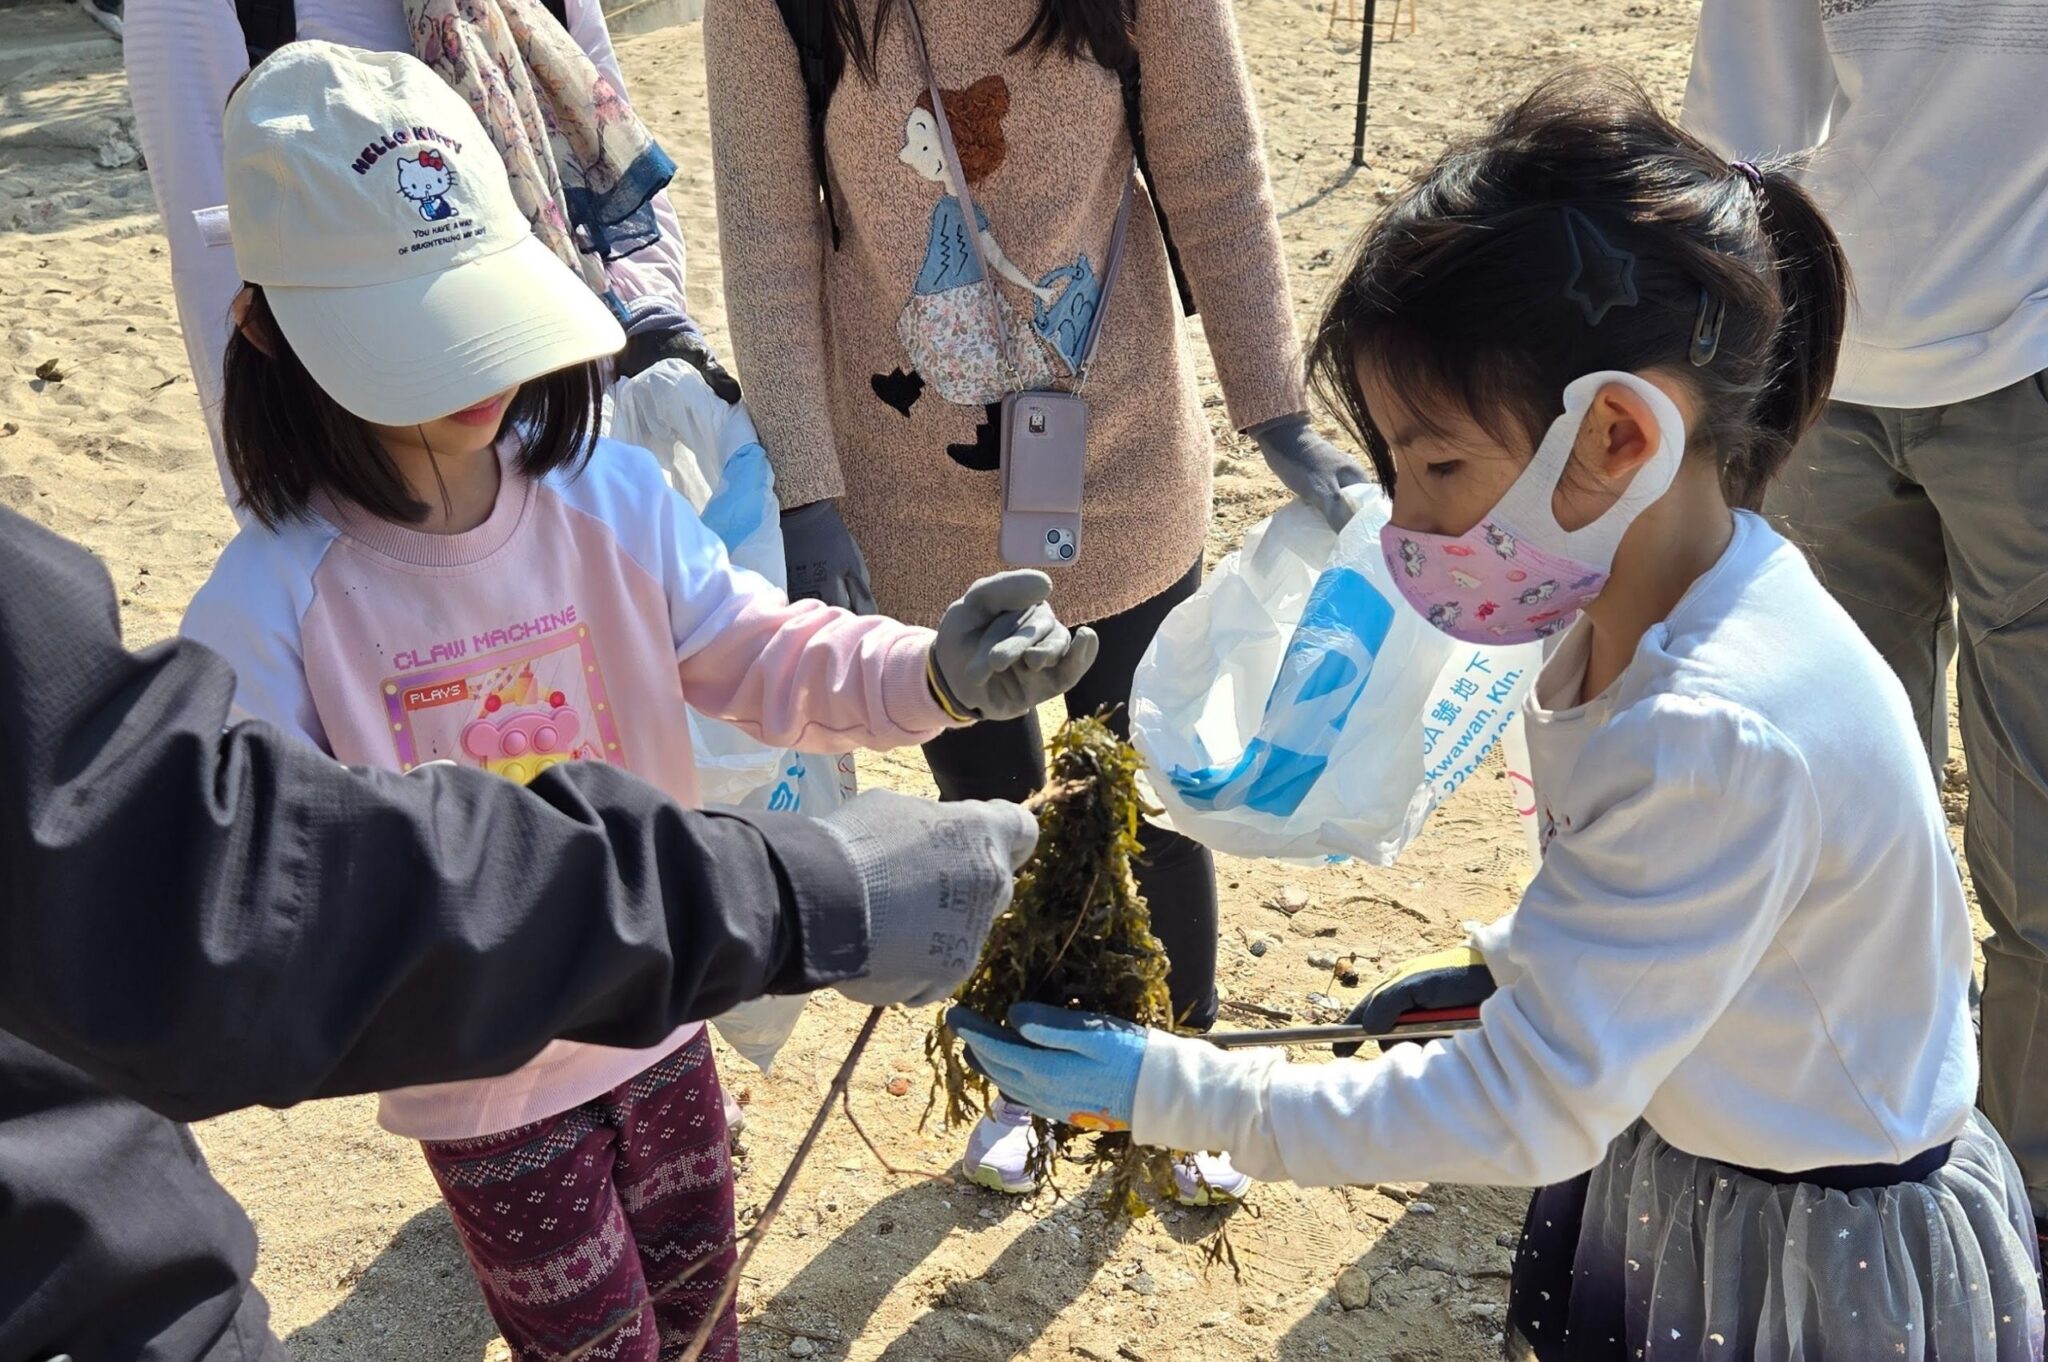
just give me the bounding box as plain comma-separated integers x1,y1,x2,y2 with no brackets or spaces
1130,487,1540,864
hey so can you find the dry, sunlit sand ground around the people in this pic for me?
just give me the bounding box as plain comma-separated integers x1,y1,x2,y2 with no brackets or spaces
0,0,1982,1362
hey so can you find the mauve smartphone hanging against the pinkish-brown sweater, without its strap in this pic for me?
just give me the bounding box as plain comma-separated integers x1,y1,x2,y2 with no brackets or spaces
997,393,1087,567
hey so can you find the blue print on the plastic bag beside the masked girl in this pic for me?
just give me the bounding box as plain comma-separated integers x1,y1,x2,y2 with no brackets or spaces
1169,567,1395,817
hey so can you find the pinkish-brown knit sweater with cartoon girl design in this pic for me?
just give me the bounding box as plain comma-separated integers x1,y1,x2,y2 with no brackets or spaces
705,0,1305,623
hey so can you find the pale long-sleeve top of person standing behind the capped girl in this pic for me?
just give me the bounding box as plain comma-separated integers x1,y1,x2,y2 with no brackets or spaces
123,0,688,502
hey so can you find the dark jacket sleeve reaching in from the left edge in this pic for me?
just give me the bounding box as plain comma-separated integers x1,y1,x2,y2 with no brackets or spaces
0,510,866,1120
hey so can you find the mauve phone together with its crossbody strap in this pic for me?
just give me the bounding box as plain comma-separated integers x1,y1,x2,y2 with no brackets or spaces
903,0,1137,567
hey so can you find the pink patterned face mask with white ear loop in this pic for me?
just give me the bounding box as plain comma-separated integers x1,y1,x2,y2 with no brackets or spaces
1380,371,1686,647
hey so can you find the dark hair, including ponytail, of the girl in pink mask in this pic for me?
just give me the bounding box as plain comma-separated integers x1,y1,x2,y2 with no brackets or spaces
1309,68,1849,510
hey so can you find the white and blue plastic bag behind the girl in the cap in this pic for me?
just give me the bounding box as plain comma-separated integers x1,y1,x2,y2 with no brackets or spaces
608,360,854,1073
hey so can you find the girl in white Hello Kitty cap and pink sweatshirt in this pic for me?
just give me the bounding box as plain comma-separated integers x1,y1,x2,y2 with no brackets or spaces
186,43,1096,1362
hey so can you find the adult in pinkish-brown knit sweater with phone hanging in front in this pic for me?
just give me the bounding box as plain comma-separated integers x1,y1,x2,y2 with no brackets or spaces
705,0,1364,1192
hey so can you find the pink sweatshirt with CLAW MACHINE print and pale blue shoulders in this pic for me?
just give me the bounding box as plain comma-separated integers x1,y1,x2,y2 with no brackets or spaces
184,440,946,1141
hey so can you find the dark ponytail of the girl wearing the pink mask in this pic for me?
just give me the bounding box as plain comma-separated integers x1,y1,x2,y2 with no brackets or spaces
1724,160,1849,508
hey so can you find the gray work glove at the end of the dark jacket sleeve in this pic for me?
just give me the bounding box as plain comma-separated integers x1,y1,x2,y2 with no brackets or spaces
819,791,1038,1008
